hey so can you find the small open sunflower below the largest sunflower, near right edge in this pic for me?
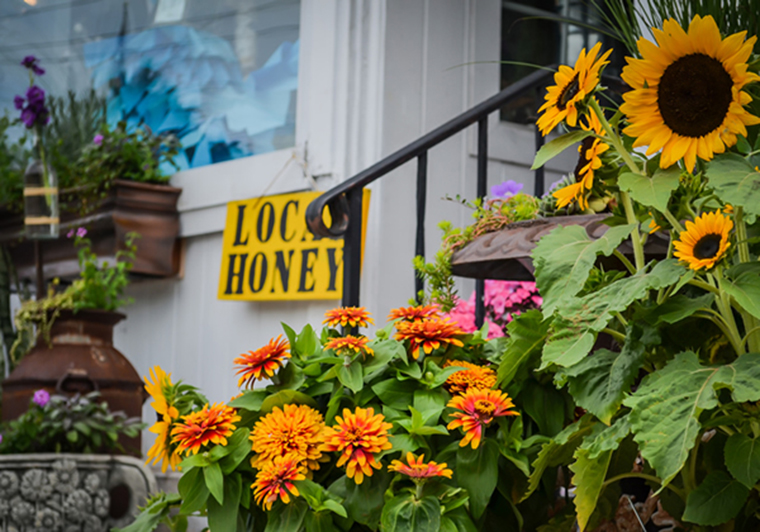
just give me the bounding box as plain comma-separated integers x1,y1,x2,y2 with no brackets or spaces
673,211,734,270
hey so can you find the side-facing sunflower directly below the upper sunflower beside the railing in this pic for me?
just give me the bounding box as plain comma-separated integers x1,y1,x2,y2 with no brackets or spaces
552,113,610,211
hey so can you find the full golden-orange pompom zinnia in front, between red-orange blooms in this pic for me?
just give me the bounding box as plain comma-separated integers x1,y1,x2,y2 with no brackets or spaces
250,405,325,470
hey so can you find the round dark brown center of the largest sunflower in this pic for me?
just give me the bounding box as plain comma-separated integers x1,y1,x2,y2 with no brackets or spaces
657,54,733,137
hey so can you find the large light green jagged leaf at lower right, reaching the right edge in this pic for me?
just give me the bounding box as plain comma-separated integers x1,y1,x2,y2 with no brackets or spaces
623,351,760,486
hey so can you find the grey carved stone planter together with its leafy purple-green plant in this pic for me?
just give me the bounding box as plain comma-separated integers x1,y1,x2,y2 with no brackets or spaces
0,389,155,532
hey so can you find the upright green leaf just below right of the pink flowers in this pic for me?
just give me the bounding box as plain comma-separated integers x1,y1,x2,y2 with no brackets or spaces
498,309,551,388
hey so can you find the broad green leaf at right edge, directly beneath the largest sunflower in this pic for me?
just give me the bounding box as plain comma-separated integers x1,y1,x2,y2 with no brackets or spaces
705,153,760,223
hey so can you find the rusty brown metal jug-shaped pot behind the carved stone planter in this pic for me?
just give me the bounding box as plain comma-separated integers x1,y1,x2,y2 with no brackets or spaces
2,310,147,456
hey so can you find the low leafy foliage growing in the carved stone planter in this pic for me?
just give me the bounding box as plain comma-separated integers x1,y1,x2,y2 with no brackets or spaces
0,392,144,454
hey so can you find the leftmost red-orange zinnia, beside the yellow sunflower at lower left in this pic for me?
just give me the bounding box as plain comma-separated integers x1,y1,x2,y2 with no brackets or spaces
171,403,240,454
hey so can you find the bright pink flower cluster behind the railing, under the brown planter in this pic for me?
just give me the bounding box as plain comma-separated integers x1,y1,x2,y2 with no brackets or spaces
447,280,542,338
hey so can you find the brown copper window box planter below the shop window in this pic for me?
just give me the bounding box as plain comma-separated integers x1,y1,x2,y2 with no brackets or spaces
0,180,182,280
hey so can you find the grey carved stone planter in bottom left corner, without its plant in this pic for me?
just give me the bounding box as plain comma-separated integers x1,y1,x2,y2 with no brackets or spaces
0,454,156,532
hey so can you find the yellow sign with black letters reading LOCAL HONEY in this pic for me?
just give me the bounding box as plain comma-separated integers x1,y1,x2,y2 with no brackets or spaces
219,189,369,301
